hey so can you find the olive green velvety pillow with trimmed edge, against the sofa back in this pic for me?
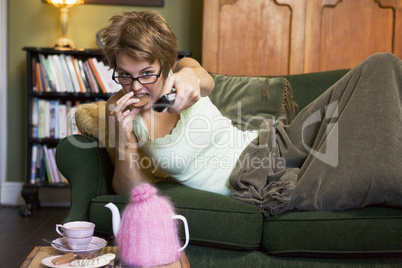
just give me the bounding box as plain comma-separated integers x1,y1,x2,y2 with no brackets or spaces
209,74,296,130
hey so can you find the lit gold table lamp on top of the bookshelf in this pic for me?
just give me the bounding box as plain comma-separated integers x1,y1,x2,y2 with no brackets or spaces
45,0,84,50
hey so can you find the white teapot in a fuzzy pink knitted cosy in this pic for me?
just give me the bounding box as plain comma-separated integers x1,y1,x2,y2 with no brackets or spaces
105,183,189,266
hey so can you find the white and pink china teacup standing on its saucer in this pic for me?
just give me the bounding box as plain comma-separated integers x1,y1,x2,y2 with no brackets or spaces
56,221,95,250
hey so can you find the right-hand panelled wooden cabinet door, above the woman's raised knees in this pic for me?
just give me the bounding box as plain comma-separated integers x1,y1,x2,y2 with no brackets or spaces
304,0,402,72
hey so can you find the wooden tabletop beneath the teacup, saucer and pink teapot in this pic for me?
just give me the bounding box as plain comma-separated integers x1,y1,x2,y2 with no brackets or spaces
21,246,190,268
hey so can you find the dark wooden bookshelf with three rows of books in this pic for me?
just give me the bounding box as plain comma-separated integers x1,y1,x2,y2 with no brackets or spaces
20,47,119,216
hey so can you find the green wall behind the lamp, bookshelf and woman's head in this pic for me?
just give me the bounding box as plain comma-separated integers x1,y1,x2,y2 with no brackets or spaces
7,0,203,182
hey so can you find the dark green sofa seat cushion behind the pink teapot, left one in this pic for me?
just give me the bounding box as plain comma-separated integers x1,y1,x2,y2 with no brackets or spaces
89,183,263,250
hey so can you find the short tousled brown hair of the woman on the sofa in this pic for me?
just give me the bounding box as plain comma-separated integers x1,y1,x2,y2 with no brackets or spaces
102,11,177,77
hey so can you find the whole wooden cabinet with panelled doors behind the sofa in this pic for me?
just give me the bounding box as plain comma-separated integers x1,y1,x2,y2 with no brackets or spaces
202,0,402,75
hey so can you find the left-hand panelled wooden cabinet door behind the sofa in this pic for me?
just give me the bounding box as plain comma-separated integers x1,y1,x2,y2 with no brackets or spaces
202,0,298,75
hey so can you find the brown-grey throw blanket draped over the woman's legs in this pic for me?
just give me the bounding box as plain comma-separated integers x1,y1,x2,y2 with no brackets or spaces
230,53,402,216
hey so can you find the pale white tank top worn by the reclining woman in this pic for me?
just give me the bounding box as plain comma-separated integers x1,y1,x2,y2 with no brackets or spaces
133,97,258,195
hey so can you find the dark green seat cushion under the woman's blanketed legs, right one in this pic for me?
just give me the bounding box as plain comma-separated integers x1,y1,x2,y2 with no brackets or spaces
262,207,402,256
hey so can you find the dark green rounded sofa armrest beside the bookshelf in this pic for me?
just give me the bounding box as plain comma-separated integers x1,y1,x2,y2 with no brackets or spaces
56,135,113,222
